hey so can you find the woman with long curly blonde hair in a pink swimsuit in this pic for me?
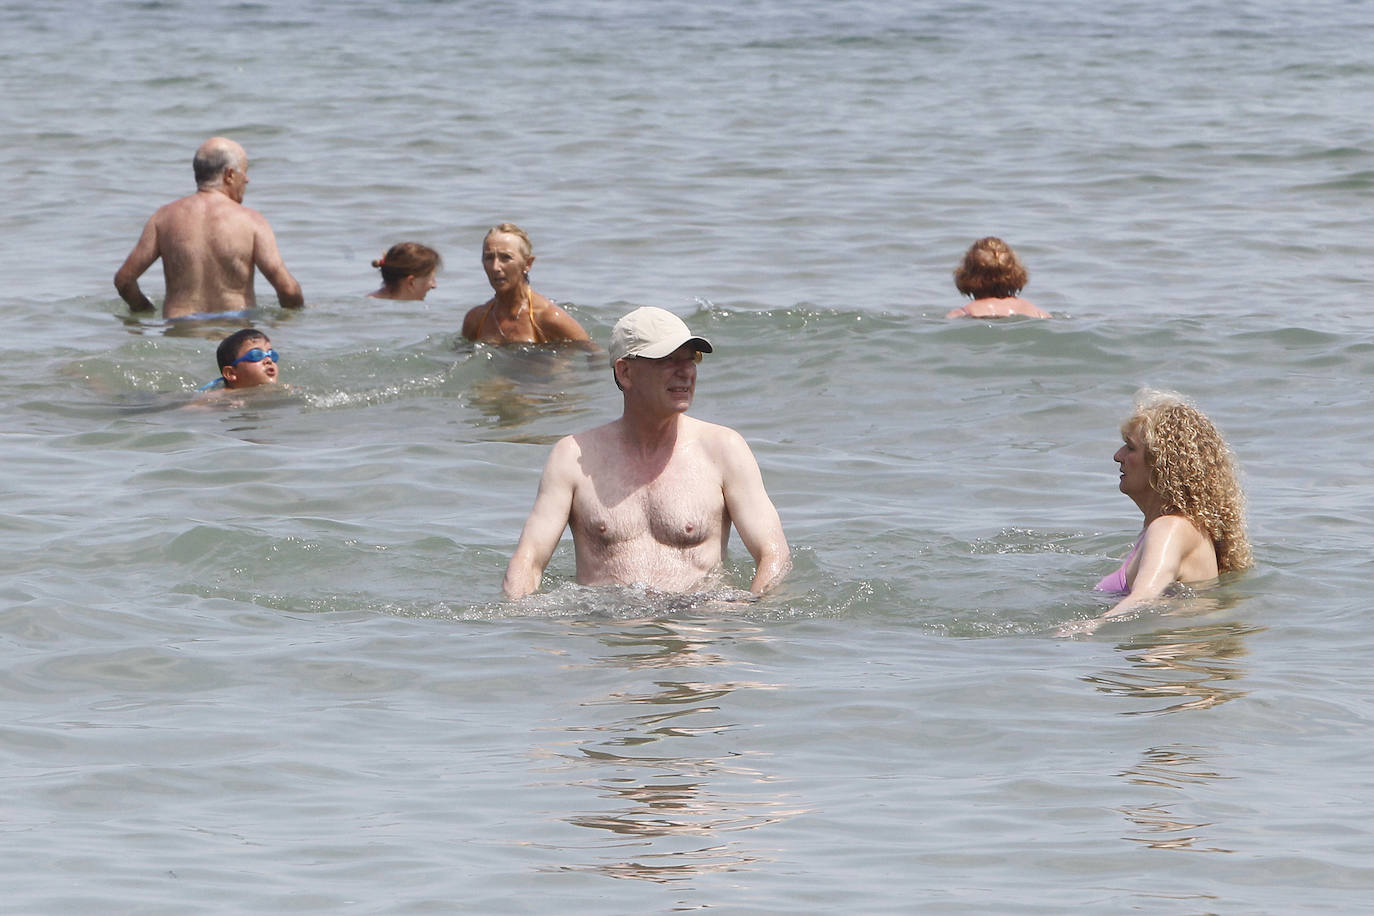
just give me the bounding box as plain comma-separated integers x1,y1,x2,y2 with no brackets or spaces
1061,390,1252,634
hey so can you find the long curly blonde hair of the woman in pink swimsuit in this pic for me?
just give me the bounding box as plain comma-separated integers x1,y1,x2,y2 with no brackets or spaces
1121,389,1253,573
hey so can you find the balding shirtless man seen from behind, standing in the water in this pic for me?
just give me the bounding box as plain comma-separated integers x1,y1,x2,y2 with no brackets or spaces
114,137,305,319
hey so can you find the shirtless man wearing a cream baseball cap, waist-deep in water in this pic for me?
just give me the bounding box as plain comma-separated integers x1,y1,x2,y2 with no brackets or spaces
503,308,791,597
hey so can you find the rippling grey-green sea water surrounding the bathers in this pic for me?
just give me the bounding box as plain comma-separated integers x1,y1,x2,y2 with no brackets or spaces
0,0,1374,916
